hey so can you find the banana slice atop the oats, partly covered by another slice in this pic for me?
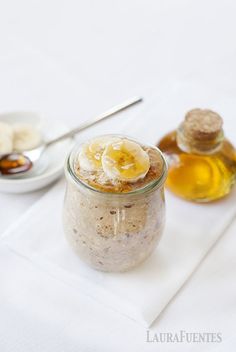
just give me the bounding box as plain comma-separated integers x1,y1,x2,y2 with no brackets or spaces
79,137,119,171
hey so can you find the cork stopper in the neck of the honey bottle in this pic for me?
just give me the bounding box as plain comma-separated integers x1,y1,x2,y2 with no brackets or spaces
182,109,223,143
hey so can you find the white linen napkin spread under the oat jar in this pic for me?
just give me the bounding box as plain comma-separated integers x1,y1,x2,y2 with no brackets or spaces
3,176,236,325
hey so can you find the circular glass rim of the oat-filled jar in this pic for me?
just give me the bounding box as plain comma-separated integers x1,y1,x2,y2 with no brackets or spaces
65,134,168,197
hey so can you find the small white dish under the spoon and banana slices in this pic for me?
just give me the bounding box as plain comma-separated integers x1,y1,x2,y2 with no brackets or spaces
0,111,73,193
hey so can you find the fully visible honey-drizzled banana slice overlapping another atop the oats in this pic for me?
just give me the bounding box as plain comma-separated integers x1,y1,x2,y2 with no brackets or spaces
102,139,150,182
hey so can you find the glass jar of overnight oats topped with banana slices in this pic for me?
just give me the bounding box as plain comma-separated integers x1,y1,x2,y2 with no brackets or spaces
63,135,167,272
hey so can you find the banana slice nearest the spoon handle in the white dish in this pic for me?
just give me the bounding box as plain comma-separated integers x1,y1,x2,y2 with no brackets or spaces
13,123,42,151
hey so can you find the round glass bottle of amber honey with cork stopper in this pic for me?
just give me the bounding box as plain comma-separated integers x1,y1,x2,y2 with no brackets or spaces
158,109,236,202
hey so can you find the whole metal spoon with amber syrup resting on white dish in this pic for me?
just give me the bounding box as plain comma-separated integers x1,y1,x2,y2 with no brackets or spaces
0,98,142,177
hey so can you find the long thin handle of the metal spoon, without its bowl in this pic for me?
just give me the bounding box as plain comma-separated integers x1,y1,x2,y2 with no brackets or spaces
45,98,143,147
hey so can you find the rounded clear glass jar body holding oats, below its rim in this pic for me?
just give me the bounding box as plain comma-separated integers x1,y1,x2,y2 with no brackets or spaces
63,138,167,272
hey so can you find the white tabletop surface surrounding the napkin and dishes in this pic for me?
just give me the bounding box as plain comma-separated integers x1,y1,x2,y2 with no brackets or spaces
0,0,236,352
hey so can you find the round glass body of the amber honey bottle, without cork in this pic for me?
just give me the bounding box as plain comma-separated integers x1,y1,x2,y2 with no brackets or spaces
158,130,236,202
